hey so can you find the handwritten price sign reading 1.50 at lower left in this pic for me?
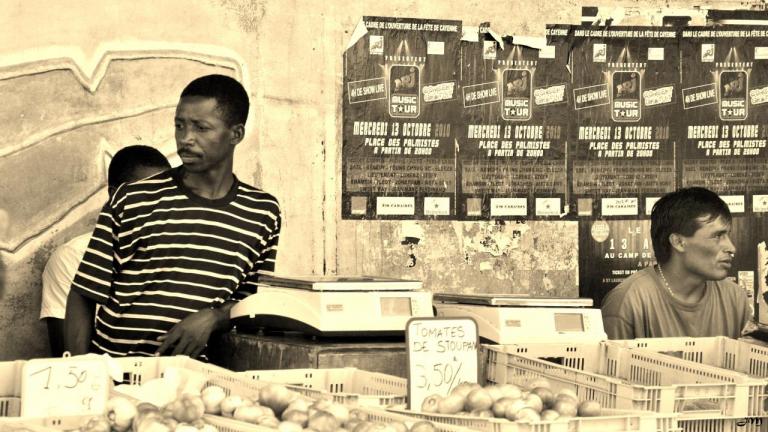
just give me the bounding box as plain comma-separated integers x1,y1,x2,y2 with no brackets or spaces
21,357,111,417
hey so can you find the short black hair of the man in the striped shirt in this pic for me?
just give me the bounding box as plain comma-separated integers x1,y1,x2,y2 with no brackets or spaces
181,74,250,126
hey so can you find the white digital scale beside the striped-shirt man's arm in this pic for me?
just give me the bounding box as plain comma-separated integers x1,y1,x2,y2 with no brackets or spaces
230,276,433,337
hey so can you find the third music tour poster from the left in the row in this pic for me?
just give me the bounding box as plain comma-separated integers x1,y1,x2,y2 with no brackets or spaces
568,26,680,218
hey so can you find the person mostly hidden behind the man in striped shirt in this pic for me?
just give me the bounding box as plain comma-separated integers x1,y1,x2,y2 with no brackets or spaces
40,145,171,357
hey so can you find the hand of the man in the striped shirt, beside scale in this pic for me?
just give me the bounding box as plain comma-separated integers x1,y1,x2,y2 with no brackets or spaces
155,309,220,357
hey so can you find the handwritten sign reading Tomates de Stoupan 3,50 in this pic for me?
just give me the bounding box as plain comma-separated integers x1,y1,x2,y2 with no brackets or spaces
405,318,478,410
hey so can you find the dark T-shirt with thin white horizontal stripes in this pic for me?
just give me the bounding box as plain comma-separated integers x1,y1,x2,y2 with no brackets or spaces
72,168,281,356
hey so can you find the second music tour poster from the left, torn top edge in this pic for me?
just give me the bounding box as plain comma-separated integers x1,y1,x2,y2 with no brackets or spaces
458,26,570,220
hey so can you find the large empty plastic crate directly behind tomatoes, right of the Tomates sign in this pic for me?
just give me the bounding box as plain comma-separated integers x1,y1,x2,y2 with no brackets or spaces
486,342,765,421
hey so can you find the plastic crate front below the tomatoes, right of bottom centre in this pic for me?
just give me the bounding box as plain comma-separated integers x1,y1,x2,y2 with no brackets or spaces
390,409,680,432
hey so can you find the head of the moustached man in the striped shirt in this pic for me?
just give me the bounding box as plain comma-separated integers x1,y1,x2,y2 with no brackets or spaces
174,75,249,172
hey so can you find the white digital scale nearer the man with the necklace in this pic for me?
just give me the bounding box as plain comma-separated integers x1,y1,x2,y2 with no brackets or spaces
434,293,608,345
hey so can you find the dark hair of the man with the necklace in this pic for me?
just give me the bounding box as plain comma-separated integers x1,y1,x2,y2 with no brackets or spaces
651,187,732,264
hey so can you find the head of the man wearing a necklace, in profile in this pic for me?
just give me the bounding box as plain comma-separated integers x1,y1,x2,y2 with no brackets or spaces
651,187,736,280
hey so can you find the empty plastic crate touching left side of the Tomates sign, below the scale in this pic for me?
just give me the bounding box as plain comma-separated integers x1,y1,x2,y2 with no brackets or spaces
239,368,408,407
